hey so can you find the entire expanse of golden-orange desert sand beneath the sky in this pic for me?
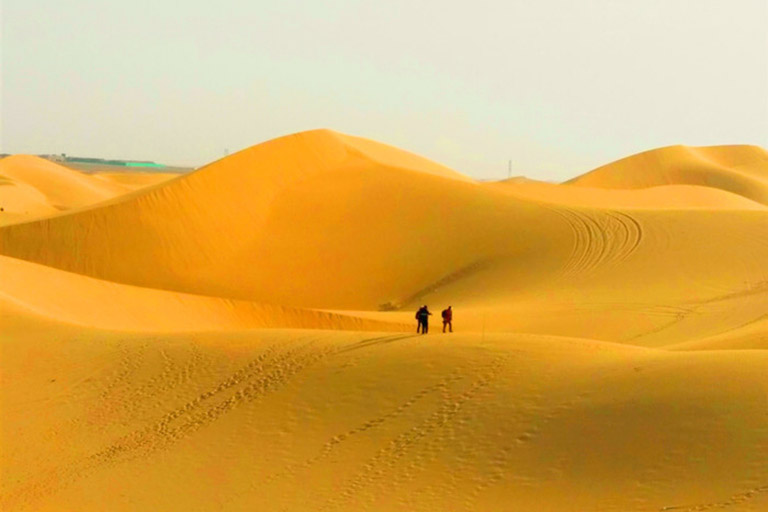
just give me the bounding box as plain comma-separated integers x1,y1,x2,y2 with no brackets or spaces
0,130,768,512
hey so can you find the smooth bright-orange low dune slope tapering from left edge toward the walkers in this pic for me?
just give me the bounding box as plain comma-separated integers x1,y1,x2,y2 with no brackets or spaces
0,256,408,332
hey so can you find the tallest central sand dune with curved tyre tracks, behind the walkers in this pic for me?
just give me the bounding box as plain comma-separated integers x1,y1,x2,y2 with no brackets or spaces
0,131,768,345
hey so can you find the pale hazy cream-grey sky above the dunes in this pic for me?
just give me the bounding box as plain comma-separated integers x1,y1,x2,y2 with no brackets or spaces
0,0,768,181
